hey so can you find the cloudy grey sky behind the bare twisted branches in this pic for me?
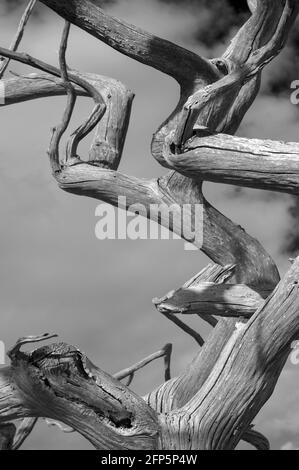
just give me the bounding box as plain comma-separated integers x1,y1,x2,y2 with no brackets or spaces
0,0,299,449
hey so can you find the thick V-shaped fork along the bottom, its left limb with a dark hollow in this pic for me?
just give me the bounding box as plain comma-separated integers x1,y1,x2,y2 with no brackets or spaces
0,252,299,450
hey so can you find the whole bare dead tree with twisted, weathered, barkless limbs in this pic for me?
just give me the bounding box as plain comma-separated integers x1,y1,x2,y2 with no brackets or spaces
0,0,299,450
